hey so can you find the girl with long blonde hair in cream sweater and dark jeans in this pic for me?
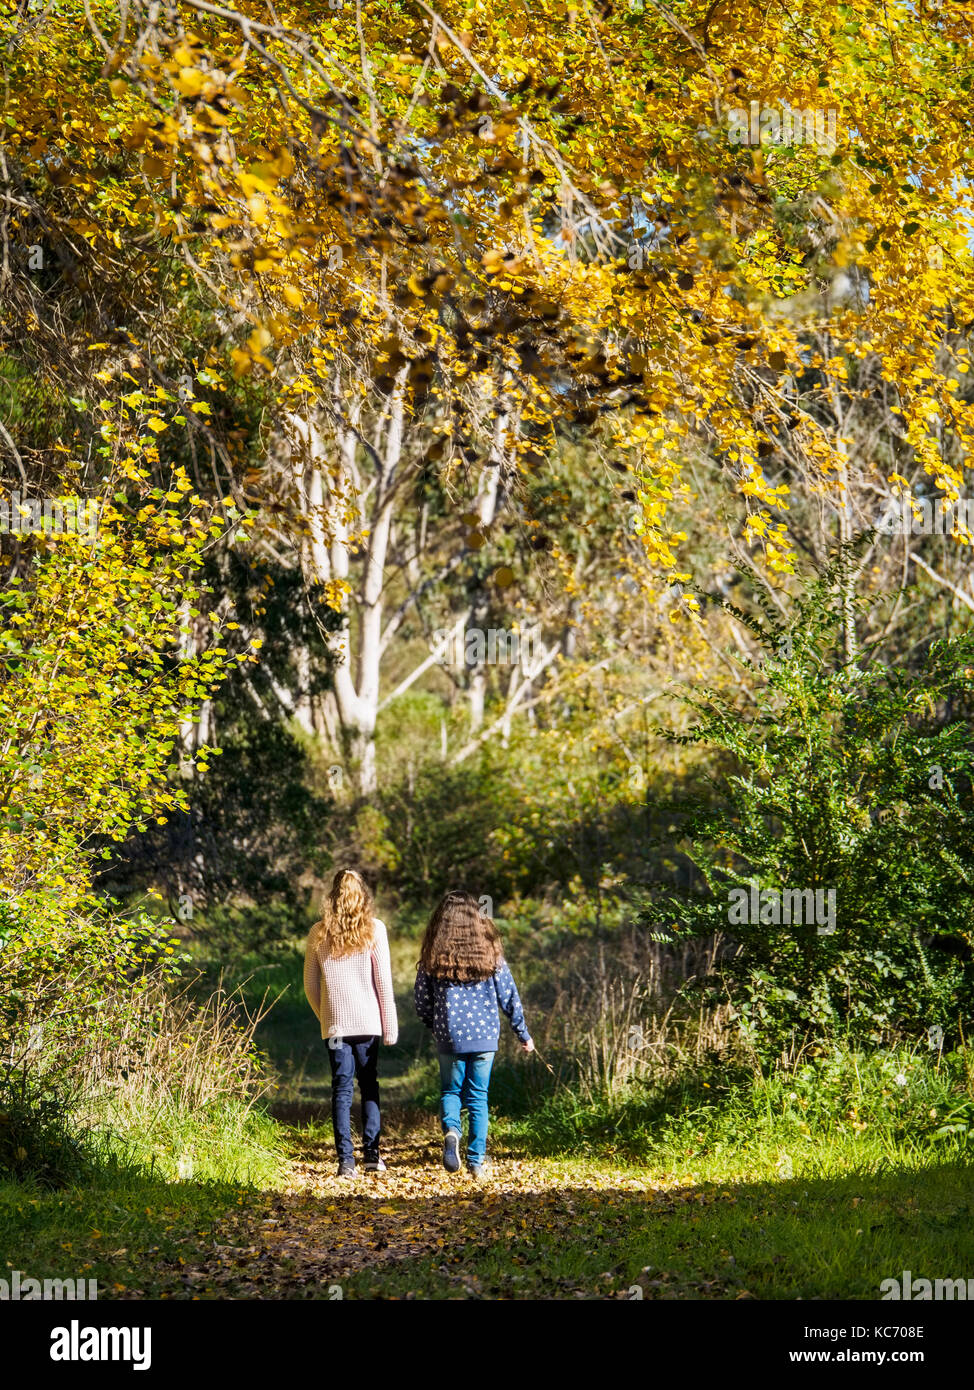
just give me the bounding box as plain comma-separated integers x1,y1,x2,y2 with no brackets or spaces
304,869,399,1177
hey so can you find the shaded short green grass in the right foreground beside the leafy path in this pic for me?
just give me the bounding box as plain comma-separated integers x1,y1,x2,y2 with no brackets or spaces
343,1163,974,1300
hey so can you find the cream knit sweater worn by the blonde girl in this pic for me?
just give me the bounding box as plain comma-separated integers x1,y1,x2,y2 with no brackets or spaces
304,917,399,1045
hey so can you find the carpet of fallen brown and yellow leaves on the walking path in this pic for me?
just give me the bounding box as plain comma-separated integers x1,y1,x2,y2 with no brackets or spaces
146,1122,689,1298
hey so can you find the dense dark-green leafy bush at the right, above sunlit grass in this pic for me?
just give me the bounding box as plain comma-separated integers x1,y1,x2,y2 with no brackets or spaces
646,555,974,1054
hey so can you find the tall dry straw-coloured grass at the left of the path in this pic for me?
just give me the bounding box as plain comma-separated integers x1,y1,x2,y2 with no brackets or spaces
0,934,281,1182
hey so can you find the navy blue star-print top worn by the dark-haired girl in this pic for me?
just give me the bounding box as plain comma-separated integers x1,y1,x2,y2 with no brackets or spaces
413,960,531,1052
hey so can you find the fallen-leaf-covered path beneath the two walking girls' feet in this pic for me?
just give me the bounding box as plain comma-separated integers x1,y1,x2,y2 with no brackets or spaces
161,1116,679,1298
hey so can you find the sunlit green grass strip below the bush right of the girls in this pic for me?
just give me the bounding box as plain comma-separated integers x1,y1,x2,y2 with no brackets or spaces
500,1048,974,1182
